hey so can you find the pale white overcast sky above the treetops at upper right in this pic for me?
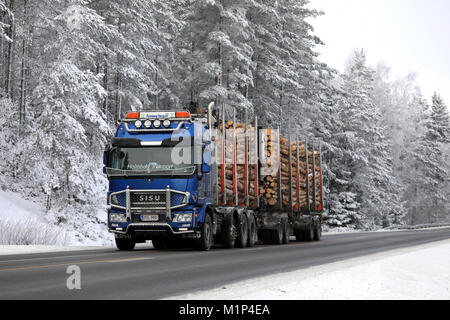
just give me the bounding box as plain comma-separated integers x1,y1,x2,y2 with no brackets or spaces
310,0,450,107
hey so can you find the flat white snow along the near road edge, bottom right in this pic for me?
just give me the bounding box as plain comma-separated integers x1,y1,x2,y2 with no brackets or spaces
170,240,450,300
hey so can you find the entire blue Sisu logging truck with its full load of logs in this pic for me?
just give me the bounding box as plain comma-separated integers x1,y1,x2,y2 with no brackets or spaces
103,103,323,251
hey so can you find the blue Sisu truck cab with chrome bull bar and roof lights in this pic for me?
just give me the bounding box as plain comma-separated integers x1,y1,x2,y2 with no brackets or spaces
104,111,212,250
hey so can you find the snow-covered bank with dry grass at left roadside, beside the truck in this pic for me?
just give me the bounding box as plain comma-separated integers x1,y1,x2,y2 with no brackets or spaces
0,190,112,246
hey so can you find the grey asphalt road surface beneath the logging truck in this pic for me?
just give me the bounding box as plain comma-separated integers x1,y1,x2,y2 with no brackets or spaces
0,228,450,300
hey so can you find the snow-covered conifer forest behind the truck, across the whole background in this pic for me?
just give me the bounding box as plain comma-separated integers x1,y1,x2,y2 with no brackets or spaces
0,0,450,241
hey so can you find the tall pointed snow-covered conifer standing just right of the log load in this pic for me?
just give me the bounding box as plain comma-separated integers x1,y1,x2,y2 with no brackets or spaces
326,51,404,229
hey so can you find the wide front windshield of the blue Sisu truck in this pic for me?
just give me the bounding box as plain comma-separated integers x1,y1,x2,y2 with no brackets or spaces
108,146,195,174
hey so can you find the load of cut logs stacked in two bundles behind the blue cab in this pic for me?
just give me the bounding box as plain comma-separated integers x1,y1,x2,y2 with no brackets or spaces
217,121,321,211
